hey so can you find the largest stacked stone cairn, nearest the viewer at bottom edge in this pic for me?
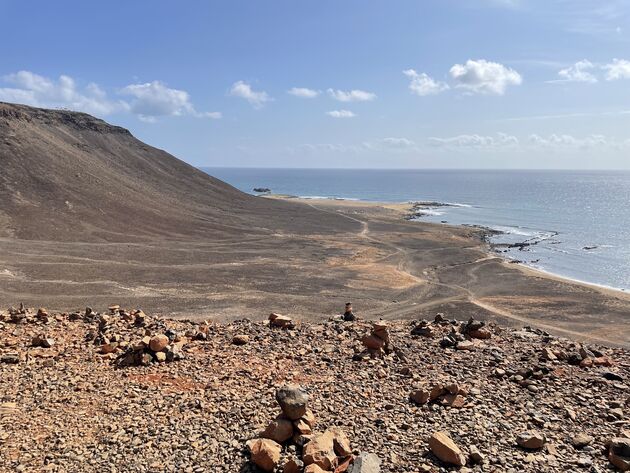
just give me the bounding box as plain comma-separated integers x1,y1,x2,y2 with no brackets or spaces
247,385,380,473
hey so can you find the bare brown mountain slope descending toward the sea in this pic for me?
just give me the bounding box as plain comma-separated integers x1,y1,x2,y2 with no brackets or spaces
0,103,357,241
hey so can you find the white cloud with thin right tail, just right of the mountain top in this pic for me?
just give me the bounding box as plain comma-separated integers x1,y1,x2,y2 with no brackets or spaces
120,80,221,122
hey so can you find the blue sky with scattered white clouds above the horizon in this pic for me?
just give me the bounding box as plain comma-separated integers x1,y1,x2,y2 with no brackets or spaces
0,0,630,169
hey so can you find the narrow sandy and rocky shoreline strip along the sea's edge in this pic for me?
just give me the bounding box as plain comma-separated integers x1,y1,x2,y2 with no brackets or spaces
266,193,630,300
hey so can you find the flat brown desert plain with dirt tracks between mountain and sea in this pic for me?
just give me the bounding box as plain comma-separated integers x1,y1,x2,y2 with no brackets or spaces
0,197,630,346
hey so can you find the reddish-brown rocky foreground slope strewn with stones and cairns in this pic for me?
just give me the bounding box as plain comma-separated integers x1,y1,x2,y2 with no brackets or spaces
0,306,630,473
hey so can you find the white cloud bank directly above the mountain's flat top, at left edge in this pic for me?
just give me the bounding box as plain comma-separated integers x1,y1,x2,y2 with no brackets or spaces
0,71,128,116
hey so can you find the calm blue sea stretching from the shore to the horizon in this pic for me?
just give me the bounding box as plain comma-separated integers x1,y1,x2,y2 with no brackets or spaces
204,168,630,289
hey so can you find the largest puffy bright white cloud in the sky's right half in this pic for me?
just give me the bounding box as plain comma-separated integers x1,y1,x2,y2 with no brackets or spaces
450,59,523,95
